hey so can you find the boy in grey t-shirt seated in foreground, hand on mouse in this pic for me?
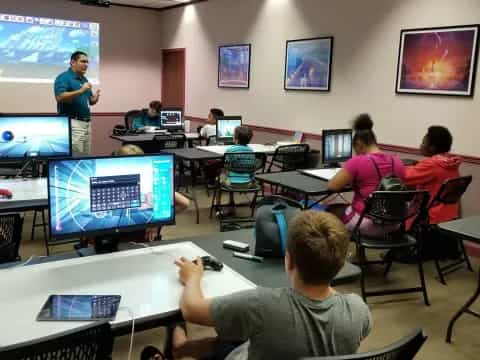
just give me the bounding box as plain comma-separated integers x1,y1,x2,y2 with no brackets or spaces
141,211,372,360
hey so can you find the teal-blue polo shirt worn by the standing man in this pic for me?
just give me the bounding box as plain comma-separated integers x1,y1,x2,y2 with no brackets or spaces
54,68,92,120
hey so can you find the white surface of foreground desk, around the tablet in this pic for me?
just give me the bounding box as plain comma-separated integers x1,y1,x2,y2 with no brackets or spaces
0,242,255,346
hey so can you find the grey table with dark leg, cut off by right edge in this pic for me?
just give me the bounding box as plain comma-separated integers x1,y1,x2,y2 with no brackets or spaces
438,216,480,343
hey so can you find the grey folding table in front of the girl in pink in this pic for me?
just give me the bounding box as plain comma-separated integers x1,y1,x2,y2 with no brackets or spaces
255,171,350,209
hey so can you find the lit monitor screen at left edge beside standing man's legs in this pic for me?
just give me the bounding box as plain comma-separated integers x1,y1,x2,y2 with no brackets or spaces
0,115,72,160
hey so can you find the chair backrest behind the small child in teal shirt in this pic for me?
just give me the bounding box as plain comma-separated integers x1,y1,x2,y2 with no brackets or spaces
223,152,267,179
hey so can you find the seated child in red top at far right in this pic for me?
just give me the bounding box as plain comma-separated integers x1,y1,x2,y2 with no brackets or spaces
405,126,462,224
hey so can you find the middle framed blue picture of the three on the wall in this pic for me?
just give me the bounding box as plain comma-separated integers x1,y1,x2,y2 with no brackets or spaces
284,36,333,91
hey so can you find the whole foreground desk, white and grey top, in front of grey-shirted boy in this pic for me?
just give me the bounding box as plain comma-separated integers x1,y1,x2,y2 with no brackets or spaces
0,229,360,344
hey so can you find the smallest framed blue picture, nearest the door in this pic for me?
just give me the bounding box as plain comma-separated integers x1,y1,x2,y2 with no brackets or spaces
218,44,252,89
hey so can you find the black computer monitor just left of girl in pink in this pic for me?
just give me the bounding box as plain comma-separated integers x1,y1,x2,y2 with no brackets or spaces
322,129,352,167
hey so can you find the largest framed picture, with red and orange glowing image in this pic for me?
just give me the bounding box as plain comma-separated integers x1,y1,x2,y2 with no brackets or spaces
396,25,479,96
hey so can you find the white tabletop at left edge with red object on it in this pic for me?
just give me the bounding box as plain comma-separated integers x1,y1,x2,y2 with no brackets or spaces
0,178,48,213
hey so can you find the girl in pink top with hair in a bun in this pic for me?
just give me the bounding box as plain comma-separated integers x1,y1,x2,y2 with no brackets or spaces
328,115,405,236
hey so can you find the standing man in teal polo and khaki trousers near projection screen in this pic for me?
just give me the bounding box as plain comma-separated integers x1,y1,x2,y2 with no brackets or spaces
54,51,100,155
